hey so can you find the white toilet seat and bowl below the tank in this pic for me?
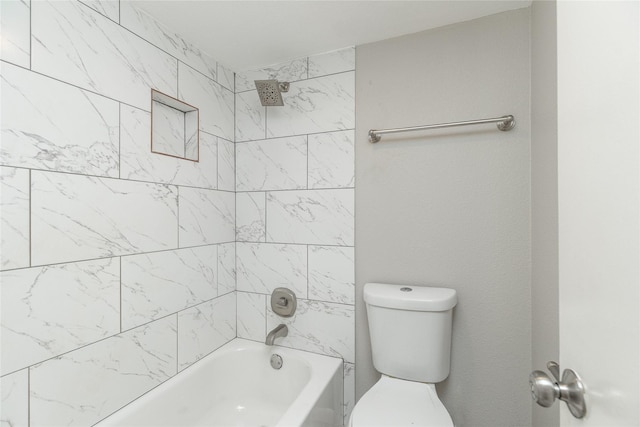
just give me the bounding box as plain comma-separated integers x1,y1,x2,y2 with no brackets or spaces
349,375,453,427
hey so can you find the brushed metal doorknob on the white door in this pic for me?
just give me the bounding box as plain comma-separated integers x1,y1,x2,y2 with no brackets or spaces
529,362,587,418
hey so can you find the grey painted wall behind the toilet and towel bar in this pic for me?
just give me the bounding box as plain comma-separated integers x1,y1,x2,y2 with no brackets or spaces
356,9,531,427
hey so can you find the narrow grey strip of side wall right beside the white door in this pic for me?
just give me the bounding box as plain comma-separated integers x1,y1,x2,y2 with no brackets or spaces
531,1,560,427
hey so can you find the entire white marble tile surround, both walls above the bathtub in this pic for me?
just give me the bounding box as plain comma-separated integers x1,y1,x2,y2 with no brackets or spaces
0,0,355,426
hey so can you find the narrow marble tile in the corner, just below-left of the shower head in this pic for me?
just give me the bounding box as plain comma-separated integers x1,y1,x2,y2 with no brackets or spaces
236,90,267,142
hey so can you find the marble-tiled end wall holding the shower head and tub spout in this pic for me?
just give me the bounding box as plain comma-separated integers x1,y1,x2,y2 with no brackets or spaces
235,48,355,420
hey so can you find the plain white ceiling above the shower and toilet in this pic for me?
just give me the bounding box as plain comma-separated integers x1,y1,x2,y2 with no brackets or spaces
136,0,531,71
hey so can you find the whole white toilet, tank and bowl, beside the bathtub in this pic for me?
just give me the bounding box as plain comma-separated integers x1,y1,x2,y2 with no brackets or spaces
349,283,457,427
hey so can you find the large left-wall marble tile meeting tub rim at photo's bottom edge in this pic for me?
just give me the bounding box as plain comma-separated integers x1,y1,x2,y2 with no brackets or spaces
30,316,177,426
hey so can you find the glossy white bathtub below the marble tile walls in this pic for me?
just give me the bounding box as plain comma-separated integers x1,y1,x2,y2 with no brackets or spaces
96,338,343,427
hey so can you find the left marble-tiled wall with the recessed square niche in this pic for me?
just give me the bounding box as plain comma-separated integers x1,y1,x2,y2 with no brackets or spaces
0,0,237,427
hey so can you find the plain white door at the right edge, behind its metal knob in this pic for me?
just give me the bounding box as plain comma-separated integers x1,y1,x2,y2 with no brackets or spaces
557,2,640,426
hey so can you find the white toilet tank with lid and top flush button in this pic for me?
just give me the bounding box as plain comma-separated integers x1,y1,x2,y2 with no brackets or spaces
364,283,457,383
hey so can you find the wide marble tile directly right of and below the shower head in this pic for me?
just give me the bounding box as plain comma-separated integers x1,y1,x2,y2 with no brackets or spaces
267,72,355,138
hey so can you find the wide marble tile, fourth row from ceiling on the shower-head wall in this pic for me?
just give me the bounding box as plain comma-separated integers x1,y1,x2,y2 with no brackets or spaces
267,189,354,246
